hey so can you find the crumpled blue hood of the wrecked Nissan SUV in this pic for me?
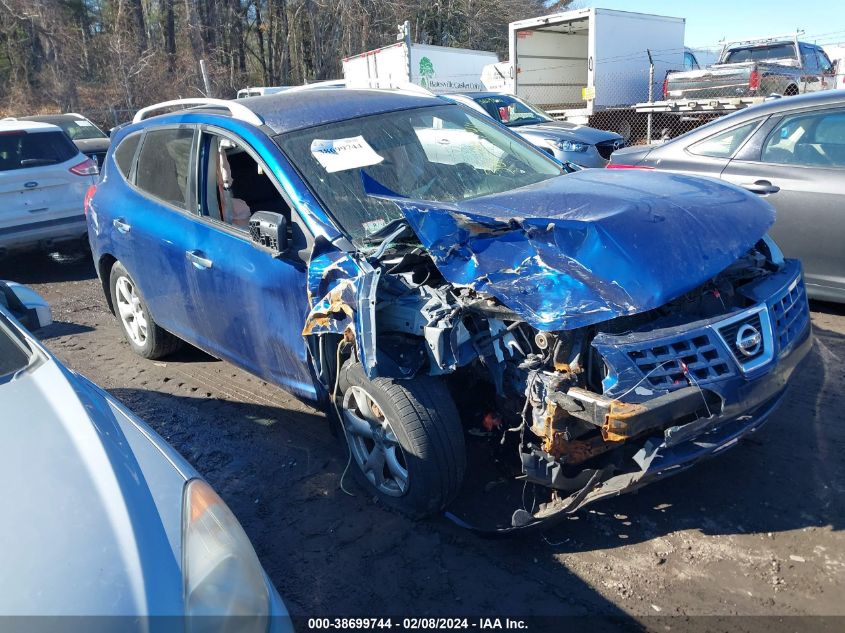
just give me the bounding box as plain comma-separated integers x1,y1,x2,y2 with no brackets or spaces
395,169,775,331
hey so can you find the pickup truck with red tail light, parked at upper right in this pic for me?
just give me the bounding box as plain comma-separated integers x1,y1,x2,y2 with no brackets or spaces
663,37,836,101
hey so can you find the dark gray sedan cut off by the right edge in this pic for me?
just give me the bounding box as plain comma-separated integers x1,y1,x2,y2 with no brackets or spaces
608,90,845,303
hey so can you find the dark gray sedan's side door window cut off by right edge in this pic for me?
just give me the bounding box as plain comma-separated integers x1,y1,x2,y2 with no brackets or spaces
761,109,845,167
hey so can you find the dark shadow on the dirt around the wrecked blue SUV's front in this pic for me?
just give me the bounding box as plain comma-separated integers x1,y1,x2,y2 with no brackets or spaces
107,316,845,631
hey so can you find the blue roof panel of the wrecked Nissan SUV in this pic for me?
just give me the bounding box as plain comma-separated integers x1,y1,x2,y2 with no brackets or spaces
238,88,438,134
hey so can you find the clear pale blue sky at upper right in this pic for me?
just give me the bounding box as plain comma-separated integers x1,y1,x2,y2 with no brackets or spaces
573,0,845,48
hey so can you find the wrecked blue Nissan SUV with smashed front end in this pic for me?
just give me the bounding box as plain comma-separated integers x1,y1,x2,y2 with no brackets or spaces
86,89,810,530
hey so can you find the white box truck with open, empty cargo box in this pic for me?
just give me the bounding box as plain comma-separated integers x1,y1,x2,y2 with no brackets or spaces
504,7,685,123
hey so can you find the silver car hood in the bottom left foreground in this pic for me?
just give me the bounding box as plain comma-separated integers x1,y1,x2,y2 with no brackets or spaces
0,355,186,615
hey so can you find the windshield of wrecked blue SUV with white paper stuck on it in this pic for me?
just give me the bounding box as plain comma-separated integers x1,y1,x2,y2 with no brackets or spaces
276,105,563,244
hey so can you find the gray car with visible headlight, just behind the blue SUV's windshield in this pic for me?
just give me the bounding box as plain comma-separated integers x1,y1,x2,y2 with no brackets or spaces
446,92,625,167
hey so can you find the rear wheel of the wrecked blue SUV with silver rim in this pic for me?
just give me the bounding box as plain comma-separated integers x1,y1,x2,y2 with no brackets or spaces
109,262,182,359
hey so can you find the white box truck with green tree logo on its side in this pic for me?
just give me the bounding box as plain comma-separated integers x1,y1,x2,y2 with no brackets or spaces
343,22,499,94
